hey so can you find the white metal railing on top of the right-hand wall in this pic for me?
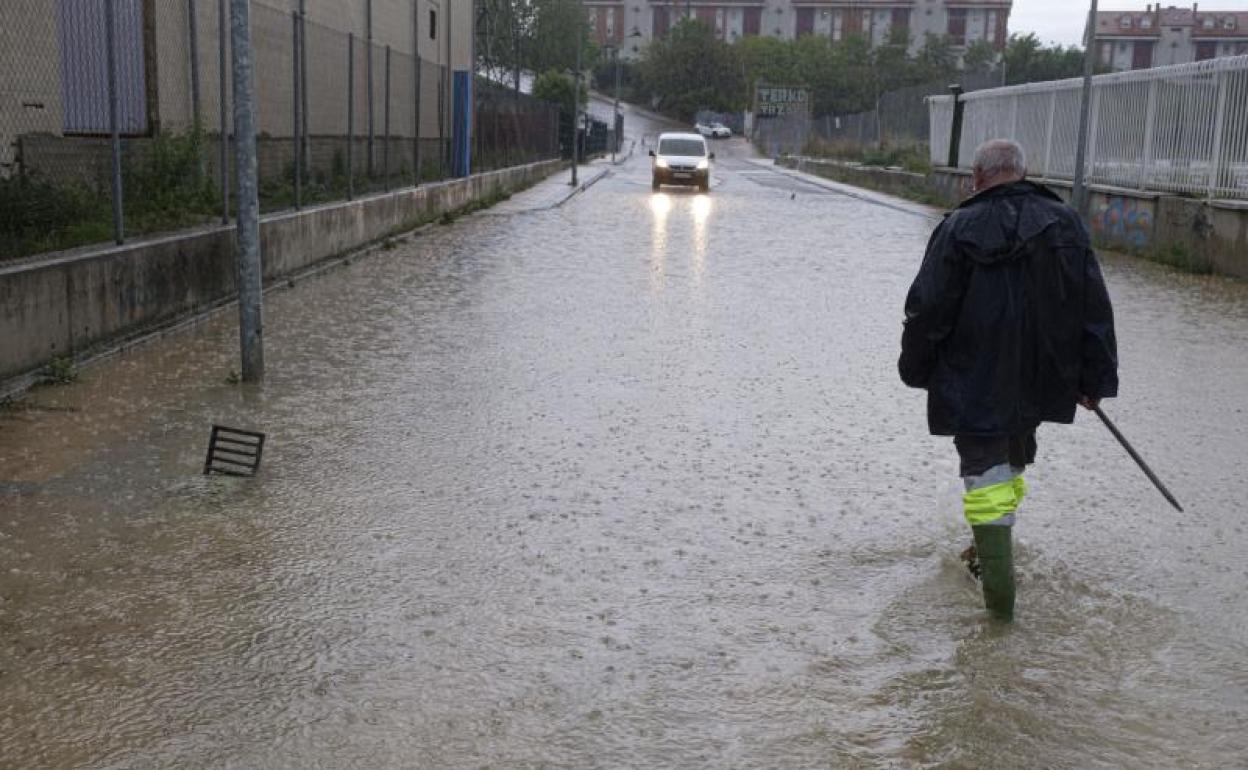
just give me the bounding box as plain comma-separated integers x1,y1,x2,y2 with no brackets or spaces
929,56,1248,198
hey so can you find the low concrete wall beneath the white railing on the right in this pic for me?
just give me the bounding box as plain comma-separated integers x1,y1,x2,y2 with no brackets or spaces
780,157,1248,278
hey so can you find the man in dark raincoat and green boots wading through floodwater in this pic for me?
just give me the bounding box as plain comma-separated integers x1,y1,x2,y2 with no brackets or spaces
899,140,1118,620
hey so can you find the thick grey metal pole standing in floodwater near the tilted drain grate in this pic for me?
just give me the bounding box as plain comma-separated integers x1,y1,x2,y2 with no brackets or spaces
229,0,265,382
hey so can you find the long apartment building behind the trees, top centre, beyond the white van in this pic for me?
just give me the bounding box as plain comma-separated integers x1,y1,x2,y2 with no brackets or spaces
584,0,1012,56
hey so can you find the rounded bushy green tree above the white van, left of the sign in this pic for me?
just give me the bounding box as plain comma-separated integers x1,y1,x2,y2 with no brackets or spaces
640,19,745,120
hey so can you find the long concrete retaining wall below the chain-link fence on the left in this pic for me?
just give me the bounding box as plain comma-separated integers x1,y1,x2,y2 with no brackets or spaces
0,161,563,389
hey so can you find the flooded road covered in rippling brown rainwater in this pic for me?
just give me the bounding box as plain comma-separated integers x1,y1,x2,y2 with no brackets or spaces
0,111,1248,768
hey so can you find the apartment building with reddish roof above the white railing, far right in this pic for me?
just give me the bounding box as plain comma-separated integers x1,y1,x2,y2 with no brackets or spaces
1096,2,1248,71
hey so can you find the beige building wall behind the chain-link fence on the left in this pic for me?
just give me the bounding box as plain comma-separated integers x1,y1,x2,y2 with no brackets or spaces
0,0,473,164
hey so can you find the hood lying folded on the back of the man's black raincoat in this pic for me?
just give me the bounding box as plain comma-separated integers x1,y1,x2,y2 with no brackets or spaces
950,180,1065,265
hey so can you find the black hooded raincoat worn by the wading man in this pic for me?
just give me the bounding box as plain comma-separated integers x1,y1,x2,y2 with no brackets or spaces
899,181,1118,436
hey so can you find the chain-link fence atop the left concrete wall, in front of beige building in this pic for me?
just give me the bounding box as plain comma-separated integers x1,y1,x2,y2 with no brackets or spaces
0,0,558,258
